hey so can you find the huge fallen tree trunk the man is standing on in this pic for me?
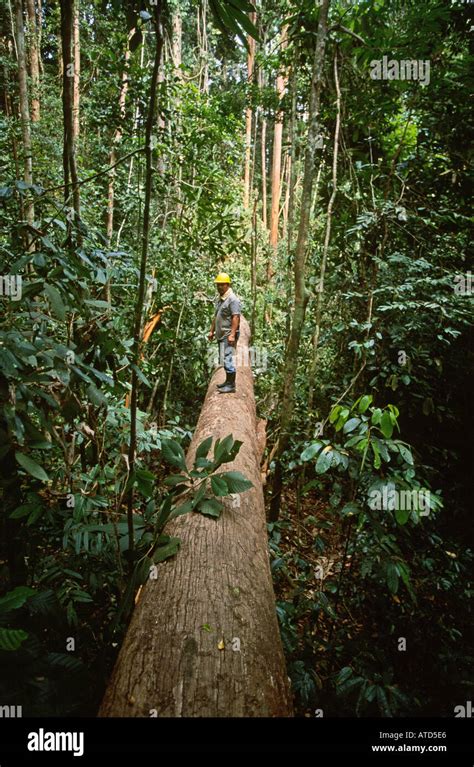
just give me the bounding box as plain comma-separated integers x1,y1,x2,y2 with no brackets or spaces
99,318,292,717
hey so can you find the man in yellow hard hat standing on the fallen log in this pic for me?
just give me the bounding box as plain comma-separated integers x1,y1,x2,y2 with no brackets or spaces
208,272,241,394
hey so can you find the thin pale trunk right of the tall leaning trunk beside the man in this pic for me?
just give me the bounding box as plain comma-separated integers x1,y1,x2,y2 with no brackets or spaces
308,49,341,411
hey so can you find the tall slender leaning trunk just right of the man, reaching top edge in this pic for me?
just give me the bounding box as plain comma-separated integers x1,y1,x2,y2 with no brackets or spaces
270,0,330,520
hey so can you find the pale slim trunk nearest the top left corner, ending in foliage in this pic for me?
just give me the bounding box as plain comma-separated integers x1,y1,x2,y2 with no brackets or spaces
14,0,35,250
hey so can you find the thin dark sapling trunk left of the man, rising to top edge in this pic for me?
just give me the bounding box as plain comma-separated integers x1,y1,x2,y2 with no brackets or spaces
127,0,163,552
